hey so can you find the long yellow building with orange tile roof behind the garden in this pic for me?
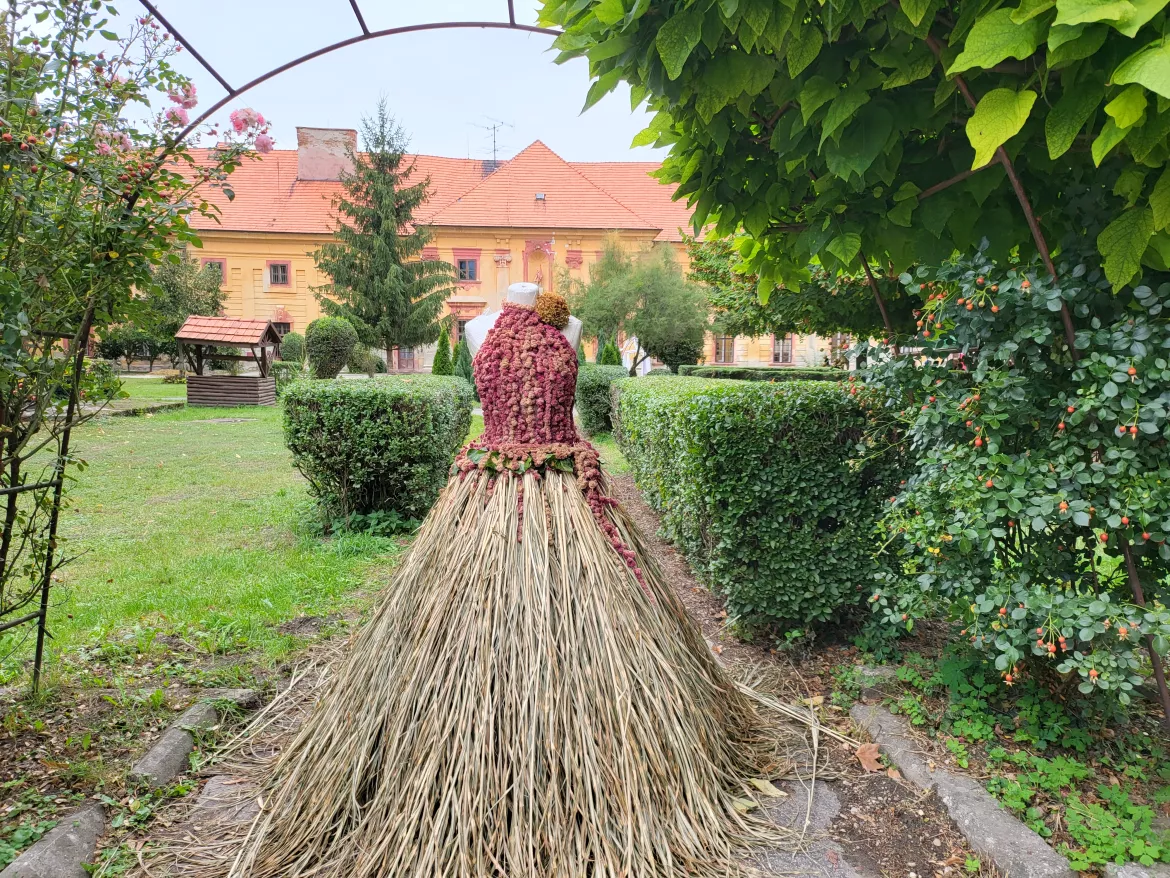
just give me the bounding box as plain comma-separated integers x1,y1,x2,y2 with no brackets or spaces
191,128,827,371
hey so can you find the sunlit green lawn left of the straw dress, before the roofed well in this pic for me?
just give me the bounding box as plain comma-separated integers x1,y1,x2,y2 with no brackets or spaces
0,405,400,679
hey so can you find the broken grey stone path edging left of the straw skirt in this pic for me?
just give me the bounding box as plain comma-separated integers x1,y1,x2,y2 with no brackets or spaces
0,690,260,878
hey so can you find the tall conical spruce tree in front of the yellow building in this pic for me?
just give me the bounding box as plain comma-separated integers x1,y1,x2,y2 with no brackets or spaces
314,101,454,358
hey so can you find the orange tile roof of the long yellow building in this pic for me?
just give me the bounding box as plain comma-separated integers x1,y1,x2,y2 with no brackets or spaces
192,140,690,241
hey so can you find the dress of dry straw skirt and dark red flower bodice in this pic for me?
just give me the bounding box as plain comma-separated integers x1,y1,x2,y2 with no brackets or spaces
223,290,771,878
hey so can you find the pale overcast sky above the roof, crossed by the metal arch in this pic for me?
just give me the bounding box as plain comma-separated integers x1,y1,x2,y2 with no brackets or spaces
134,0,662,162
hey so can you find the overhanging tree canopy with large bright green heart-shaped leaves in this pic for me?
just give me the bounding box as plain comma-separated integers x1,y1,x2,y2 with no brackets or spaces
542,0,1170,311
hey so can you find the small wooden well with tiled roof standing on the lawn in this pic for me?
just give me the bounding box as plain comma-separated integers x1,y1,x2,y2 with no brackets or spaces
174,317,281,406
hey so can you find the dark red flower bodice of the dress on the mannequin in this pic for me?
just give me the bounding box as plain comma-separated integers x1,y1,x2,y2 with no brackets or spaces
473,302,579,447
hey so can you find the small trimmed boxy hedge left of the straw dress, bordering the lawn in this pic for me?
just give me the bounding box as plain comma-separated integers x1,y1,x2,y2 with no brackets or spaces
282,375,473,520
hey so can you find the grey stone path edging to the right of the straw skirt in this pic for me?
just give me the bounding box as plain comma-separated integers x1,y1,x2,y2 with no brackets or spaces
849,704,1076,878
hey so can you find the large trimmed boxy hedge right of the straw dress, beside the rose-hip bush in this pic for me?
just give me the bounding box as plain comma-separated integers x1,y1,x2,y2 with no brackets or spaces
614,377,900,629
